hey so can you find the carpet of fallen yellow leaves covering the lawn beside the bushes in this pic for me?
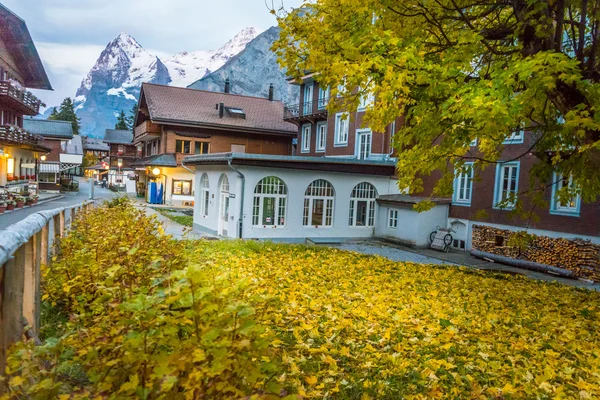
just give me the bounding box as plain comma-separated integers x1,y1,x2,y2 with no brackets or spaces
199,239,600,399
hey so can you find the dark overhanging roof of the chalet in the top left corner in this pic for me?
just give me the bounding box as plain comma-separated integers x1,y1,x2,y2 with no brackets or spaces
0,4,52,90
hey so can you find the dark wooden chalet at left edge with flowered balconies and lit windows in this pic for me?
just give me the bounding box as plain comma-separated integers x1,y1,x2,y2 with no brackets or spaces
0,4,52,191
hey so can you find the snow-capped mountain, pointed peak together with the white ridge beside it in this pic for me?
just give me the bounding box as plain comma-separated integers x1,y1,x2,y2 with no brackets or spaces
58,28,258,137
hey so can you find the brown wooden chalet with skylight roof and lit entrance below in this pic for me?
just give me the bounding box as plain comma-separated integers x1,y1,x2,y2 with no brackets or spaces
134,83,297,205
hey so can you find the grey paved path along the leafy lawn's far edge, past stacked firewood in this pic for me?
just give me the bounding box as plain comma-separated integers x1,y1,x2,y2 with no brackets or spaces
330,240,600,291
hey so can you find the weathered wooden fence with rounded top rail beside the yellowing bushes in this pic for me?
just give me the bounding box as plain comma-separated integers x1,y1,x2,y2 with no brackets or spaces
0,201,93,376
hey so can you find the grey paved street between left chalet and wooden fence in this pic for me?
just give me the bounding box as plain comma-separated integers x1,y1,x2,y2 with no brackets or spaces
0,178,117,230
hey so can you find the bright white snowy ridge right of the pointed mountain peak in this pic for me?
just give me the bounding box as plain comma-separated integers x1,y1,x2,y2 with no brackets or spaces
164,28,258,87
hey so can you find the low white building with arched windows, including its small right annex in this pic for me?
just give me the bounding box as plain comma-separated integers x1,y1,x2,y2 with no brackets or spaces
184,153,450,246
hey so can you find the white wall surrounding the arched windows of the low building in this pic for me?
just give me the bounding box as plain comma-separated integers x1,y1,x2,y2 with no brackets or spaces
194,166,398,241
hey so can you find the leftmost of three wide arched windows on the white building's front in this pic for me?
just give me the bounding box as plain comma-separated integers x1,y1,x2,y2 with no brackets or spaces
252,176,288,228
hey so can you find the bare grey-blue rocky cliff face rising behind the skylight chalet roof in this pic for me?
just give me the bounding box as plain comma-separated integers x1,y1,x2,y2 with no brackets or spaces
189,27,299,103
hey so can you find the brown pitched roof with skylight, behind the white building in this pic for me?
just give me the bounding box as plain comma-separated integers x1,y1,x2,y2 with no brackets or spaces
142,83,298,135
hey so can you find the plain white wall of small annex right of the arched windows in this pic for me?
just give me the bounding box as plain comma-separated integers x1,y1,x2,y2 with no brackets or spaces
375,204,448,247
